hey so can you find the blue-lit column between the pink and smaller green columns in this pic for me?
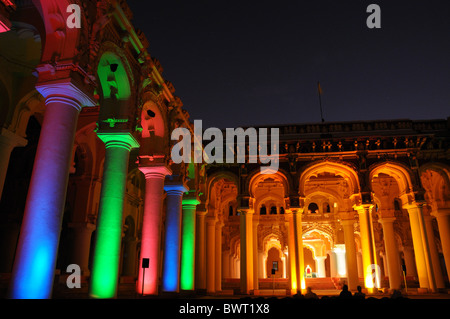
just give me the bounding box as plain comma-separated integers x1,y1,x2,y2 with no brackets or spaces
162,182,188,292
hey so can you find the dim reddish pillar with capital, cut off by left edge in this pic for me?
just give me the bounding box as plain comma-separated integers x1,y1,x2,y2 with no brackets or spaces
0,128,28,199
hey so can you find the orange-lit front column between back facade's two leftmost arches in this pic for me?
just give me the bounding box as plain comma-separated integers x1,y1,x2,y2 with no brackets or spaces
239,209,253,294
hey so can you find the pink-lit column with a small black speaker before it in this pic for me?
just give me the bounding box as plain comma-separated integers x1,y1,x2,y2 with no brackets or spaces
136,165,172,295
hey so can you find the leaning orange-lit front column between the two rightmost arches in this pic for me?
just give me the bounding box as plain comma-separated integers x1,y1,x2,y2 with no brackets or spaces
403,202,436,291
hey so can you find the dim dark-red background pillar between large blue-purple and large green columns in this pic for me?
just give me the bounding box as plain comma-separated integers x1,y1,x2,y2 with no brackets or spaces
69,223,95,276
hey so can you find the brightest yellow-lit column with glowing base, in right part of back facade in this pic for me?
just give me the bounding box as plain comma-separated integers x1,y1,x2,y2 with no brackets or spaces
355,204,380,291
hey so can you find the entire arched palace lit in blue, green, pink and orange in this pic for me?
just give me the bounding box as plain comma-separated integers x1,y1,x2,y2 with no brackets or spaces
0,0,450,298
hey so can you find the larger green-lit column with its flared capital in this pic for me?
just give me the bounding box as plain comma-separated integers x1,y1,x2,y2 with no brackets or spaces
90,133,139,298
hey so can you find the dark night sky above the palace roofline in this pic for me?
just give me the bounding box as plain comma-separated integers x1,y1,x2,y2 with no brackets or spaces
128,0,450,128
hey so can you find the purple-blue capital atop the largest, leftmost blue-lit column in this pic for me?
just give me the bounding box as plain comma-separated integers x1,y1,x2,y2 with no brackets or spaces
36,78,97,111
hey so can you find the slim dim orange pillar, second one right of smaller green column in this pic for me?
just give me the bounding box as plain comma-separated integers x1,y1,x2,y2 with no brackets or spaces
206,217,216,293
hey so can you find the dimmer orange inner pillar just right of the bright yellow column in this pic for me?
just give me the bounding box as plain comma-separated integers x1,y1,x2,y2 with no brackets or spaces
379,217,402,290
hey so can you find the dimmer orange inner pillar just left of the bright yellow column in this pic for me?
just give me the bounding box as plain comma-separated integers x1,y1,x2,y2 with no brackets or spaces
341,219,359,290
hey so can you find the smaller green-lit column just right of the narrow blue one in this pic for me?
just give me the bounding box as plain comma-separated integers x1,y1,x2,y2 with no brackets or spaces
180,197,200,290
